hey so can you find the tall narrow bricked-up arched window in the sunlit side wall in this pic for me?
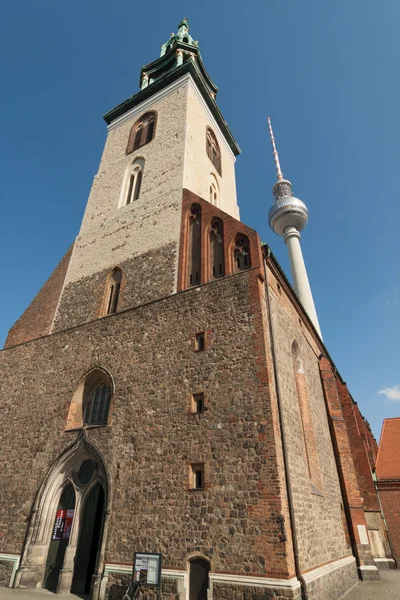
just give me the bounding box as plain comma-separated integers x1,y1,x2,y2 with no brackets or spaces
292,341,321,489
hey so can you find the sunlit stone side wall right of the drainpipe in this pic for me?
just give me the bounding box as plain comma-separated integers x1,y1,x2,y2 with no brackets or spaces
268,262,351,571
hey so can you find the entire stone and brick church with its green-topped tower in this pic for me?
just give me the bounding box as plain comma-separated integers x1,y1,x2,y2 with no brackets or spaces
0,20,393,600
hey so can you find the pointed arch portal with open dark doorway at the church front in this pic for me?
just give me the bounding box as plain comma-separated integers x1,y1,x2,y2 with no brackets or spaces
15,433,110,598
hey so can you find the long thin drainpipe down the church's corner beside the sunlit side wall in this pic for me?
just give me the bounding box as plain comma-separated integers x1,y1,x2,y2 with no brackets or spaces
264,248,308,600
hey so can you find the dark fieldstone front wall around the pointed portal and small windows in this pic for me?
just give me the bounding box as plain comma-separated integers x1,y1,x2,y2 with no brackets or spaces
0,270,294,577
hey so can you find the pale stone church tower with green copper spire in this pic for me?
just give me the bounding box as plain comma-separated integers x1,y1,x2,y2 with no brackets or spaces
47,19,239,332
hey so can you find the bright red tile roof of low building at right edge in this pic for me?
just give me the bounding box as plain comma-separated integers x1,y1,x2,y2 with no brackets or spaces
376,417,400,479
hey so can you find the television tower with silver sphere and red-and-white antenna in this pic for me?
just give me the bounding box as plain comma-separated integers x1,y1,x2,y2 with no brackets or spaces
268,117,322,339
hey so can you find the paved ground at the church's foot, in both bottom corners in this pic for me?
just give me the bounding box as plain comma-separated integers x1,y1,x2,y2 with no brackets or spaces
0,569,400,600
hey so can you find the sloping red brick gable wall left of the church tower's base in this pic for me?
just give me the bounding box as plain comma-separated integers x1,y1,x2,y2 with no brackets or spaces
4,246,73,348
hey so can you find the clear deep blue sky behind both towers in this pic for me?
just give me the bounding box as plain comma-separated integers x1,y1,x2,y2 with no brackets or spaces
0,0,400,436
